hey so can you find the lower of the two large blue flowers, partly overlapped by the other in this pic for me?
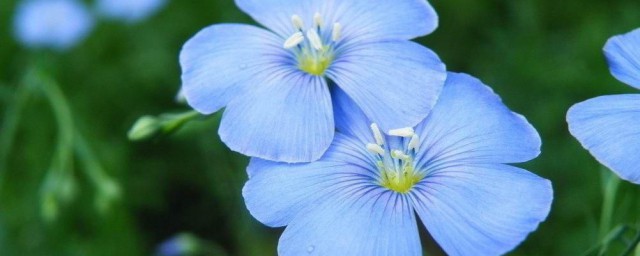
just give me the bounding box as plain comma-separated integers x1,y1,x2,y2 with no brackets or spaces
243,73,552,256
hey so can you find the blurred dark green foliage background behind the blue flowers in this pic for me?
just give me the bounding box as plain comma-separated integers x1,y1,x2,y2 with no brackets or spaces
0,0,640,255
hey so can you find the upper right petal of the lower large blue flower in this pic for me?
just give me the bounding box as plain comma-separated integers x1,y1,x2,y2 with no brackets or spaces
415,73,541,169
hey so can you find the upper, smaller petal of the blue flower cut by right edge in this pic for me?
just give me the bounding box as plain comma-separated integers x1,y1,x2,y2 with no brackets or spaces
604,29,640,88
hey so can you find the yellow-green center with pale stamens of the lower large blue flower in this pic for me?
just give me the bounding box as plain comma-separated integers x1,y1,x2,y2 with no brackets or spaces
366,123,424,193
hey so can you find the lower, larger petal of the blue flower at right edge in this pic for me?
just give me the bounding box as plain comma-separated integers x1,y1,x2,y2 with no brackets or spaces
567,95,640,184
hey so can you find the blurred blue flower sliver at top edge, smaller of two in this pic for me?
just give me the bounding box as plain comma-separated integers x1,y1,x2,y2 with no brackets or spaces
97,0,168,23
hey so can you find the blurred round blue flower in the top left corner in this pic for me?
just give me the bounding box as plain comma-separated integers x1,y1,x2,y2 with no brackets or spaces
14,0,94,50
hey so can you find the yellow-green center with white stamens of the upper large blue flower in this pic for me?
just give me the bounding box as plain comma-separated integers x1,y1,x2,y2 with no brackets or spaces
283,12,342,76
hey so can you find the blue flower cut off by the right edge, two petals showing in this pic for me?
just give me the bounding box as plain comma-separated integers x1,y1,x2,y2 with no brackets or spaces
567,29,640,184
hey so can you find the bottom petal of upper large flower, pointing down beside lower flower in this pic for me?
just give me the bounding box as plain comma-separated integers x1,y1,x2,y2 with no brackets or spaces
219,73,335,163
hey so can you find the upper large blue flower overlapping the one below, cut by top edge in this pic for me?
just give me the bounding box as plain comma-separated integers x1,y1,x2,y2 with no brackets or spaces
180,0,446,162
